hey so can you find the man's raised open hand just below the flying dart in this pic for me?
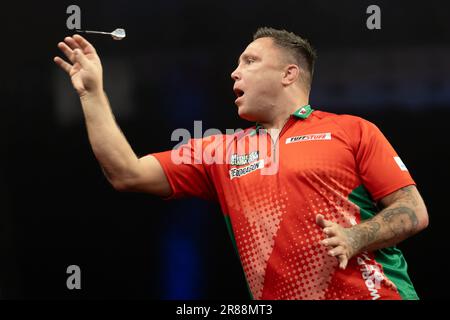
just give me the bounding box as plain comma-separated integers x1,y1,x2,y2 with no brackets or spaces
53,34,103,97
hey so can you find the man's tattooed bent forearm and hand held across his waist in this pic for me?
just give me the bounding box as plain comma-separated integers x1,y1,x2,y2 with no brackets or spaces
316,185,428,269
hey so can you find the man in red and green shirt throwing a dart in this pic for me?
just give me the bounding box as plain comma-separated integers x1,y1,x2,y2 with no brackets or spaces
54,28,428,300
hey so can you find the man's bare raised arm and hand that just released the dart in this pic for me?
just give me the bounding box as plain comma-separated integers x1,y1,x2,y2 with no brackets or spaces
54,35,171,196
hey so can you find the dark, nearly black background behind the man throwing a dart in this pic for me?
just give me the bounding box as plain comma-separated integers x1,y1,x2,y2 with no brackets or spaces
0,0,450,299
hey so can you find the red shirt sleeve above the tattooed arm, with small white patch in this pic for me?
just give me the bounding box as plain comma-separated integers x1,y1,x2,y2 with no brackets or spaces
353,118,415,201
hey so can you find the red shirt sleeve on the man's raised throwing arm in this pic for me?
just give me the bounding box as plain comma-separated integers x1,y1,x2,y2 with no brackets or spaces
152,139,217,200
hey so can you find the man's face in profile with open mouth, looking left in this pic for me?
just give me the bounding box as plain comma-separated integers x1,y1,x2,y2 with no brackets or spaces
231,38,284,121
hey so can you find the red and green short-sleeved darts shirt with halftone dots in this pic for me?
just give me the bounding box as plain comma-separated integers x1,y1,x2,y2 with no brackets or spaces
153,105,418,300
